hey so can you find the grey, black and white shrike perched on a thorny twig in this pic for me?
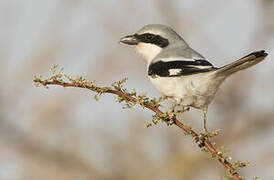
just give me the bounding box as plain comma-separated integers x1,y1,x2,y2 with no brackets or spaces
120,24,268,133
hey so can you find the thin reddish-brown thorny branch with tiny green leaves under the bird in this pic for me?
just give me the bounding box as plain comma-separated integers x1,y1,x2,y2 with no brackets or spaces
33,65,248,180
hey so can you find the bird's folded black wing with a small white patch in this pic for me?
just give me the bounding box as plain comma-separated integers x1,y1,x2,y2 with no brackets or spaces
148,60,216,77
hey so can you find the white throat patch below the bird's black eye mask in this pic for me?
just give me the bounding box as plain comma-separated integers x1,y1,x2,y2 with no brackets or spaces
136,43,162,63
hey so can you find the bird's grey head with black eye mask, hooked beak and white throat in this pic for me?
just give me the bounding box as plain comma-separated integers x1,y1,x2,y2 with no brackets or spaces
120,24,187,61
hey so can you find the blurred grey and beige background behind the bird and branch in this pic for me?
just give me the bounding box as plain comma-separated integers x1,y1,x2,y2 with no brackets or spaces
0,0,274,180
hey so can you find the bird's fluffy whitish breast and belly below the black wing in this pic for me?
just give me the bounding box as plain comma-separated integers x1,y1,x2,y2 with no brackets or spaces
150,72,223,109
